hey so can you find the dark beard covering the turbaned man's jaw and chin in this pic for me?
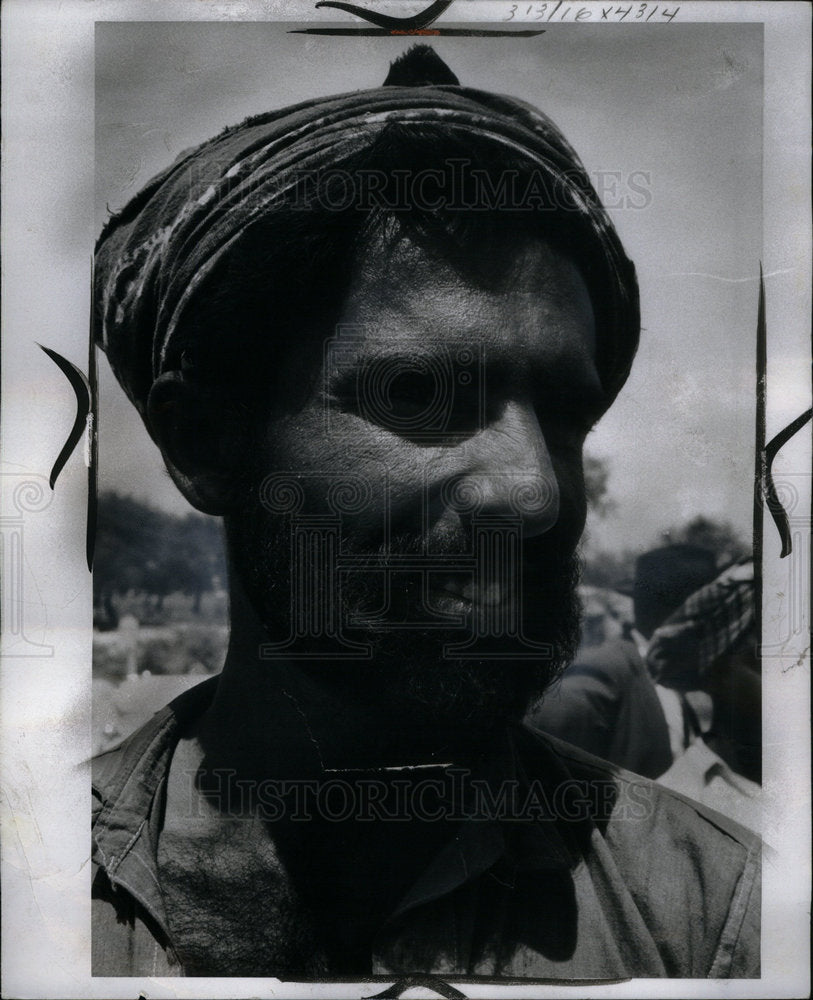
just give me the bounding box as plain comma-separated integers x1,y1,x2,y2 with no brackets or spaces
227,508,581,742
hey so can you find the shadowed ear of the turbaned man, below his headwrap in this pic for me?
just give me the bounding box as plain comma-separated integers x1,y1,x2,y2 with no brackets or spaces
147,372,249,515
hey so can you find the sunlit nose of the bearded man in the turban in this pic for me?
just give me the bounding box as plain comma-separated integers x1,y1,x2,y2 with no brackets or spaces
452,402,560,538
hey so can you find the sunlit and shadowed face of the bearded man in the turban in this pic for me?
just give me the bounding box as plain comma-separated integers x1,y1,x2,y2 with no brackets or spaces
230,227,603,744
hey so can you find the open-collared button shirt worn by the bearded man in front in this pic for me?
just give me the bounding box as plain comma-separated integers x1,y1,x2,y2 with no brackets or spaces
93,678,760,980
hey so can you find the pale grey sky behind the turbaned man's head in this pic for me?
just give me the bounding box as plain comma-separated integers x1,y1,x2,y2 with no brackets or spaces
95,22,763,549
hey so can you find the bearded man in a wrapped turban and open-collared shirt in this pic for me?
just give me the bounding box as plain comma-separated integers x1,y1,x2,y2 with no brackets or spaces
93,47,759,980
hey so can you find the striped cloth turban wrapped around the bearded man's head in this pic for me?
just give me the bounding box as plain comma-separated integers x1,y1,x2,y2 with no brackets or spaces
94,51,640,416
